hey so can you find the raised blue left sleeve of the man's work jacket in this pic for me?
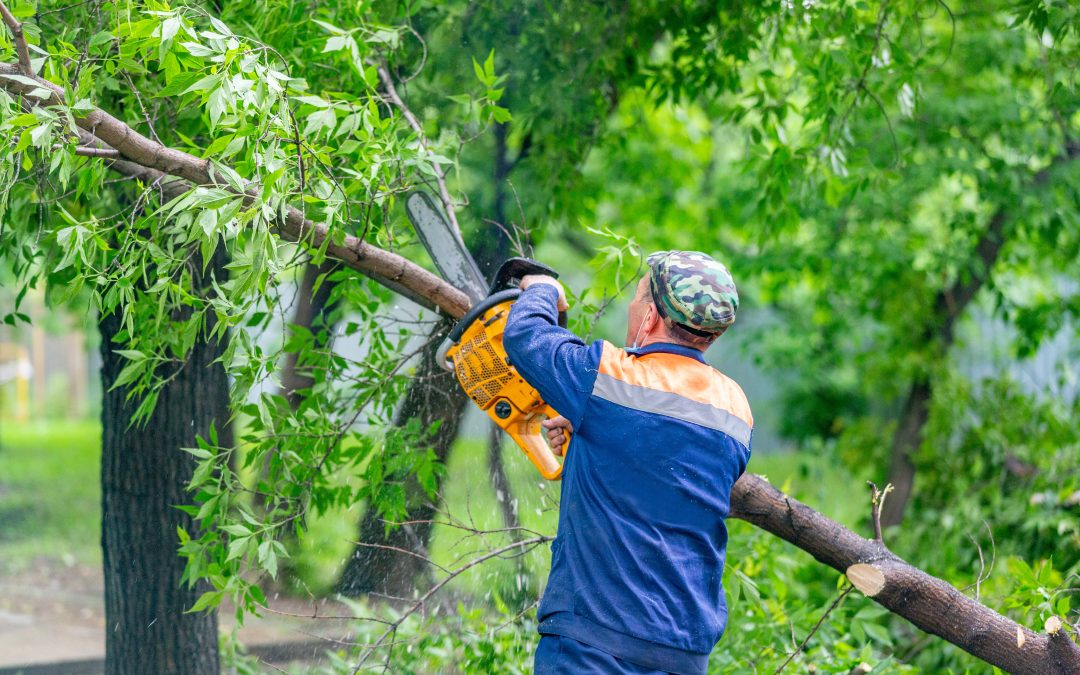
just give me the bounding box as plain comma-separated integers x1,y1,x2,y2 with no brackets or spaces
502,284,604,429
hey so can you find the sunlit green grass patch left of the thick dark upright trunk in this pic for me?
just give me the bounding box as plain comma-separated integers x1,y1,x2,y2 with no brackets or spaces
0,420,102,571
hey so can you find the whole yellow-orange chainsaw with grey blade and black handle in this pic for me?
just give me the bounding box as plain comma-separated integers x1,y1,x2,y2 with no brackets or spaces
405,190,570,481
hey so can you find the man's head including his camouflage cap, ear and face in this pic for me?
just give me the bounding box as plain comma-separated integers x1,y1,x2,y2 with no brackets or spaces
626,251,739,351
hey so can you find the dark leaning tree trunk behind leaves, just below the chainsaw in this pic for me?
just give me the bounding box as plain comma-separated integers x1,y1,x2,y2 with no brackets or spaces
337,324,469,597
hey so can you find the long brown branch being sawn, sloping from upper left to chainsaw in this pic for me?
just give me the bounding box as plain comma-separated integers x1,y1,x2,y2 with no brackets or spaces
0,64,469,318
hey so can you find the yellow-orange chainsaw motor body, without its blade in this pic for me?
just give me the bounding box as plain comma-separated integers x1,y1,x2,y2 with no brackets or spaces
446,300,570,481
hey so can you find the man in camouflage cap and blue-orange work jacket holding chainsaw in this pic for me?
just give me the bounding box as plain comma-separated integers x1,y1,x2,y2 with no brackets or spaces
503,251,754,675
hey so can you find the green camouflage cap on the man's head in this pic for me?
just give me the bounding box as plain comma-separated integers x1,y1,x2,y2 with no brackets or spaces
648,251,739,337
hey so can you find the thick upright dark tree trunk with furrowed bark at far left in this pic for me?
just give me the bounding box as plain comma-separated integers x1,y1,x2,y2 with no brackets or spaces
100,254,231,675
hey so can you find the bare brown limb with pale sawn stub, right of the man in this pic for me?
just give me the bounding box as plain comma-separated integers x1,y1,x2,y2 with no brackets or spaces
731,474,1080,675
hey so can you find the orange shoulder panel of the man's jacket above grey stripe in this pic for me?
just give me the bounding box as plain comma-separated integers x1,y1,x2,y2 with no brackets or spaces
599,342,754,427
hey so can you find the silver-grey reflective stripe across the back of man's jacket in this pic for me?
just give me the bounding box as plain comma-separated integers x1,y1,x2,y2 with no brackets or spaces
593,373,751,448
